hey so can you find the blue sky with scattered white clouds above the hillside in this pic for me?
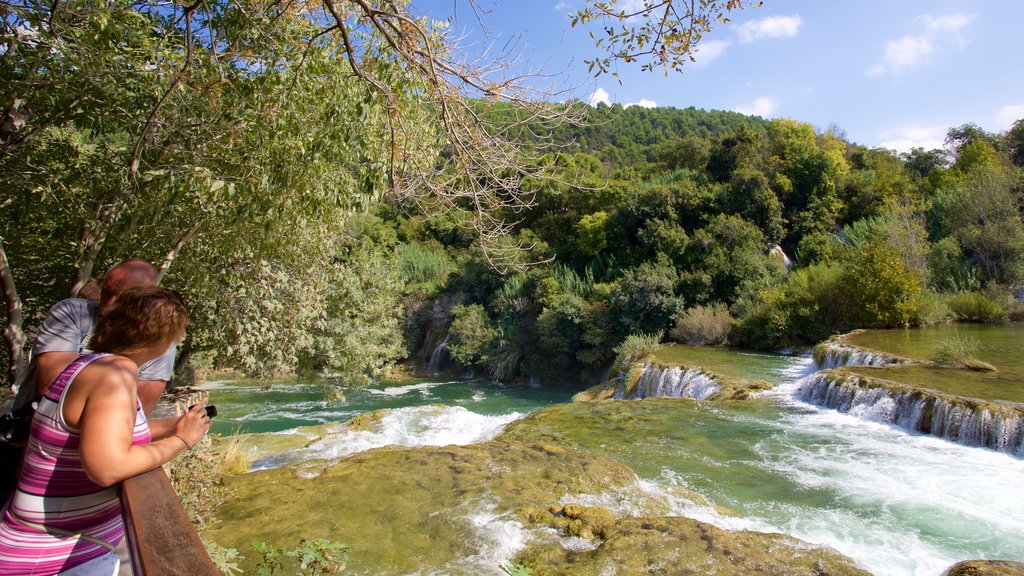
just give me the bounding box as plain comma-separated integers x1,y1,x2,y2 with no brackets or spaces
412,0,1024,152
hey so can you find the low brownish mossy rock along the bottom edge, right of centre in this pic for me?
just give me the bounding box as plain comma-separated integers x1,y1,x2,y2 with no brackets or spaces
515,517,869,576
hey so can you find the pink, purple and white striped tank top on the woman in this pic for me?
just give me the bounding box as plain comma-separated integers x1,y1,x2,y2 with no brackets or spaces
0,354,152,576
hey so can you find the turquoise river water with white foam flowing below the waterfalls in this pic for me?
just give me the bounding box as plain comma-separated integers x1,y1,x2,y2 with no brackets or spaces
210,355,1024,576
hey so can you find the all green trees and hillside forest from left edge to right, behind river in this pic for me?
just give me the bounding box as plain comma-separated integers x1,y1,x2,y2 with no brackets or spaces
0,2,1024,385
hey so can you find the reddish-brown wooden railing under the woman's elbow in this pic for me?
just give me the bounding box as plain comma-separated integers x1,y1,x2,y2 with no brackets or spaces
121,468,217,576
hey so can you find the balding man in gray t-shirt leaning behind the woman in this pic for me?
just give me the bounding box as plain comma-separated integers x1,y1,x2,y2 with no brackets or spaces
27,258,175,416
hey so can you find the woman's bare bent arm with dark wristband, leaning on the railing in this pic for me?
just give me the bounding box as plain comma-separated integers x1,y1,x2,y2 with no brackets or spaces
78,362,210,486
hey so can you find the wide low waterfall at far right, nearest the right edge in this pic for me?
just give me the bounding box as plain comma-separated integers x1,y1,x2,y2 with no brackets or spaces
795,372,1024,456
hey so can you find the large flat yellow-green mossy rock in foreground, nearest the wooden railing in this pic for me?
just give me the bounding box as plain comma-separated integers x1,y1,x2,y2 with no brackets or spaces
207,442,636,574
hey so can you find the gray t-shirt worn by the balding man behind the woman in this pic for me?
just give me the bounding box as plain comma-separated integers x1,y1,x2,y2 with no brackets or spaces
32,298,175,381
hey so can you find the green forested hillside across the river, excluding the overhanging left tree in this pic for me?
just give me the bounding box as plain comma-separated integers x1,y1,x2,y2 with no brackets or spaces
382,105,1024,380
